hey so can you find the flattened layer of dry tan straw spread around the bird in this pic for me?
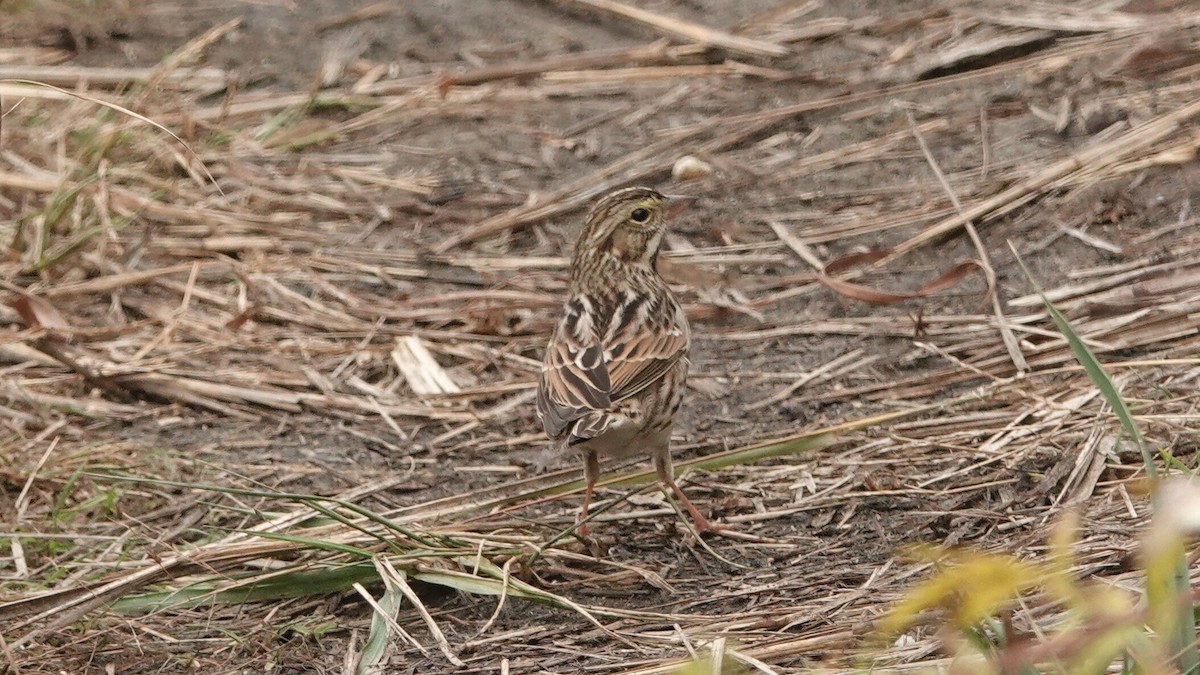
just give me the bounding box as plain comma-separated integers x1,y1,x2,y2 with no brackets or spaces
0,0,1200,674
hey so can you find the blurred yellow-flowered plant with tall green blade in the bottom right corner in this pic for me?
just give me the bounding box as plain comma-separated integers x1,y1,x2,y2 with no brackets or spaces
881,251,1200,675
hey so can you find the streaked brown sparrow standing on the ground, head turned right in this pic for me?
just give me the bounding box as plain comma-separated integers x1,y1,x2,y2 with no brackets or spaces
538,187,712,533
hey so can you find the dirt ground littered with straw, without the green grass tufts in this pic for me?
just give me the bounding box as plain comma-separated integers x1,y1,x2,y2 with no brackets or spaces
0,0,1200,673
